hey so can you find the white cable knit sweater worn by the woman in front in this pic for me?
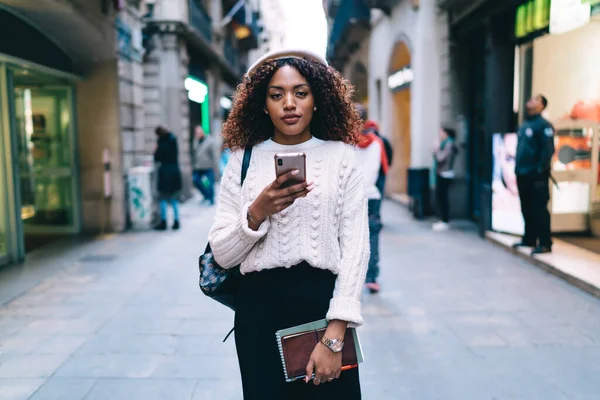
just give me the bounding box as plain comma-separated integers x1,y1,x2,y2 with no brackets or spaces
209,138,369,326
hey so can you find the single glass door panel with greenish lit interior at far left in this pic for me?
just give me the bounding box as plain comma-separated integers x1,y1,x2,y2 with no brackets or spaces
12,69,79,251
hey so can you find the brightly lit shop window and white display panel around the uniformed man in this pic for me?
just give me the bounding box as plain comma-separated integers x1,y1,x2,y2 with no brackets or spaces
492,1,600,244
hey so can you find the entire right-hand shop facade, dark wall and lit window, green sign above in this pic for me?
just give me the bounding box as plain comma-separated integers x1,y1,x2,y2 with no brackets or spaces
441,0,600,235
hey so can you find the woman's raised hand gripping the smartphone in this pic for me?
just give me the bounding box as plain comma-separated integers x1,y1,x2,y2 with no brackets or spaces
248,170,314,230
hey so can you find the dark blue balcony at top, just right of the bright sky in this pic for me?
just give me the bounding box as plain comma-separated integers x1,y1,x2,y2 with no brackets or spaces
329,0,371,63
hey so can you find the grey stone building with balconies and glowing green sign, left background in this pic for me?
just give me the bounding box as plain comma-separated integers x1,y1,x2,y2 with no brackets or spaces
144,0,260,196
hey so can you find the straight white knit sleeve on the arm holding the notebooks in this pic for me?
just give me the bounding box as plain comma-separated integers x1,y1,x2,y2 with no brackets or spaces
327,149,370,327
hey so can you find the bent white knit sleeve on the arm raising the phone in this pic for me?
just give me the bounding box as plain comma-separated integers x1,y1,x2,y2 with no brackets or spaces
208,151,269,268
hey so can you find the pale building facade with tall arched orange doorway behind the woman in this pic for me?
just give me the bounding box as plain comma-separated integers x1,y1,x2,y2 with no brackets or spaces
329,0,454,214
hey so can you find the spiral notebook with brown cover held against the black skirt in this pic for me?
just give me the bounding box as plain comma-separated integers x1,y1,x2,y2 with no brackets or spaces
275,319,363,382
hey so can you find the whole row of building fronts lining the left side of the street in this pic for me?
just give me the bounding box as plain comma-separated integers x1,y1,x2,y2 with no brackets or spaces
0,0,259,265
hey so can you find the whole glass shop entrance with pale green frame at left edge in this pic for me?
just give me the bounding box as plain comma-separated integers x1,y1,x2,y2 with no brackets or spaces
0,58,80,263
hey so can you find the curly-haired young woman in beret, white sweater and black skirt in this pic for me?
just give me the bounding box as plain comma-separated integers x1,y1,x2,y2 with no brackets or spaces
209,51,369,400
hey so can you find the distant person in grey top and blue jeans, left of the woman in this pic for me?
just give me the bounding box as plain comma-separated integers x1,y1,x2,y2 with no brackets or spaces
193,125,220,206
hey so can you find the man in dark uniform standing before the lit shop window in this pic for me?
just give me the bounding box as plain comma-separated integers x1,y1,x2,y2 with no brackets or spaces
514,94,554,254
